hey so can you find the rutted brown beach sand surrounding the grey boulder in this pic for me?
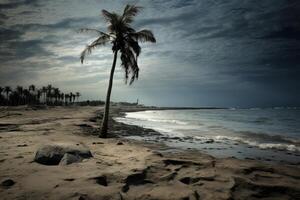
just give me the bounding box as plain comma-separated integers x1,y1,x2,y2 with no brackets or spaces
0,107,300,200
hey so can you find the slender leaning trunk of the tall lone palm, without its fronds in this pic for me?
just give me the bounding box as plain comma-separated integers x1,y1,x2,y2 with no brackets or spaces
99,51,118,138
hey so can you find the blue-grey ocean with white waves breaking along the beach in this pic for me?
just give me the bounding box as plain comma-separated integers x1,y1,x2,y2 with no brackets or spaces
115,108,300,163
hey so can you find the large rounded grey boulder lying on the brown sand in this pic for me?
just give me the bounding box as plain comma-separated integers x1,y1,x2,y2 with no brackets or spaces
34,144,93,165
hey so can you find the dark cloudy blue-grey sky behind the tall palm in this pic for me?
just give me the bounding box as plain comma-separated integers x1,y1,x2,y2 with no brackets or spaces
0,0,300,107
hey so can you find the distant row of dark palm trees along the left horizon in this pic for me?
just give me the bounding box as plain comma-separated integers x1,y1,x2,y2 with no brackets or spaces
0,85,81,106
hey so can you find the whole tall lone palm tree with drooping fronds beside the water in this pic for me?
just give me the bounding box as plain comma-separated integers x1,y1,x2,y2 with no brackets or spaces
80,5,156,137
